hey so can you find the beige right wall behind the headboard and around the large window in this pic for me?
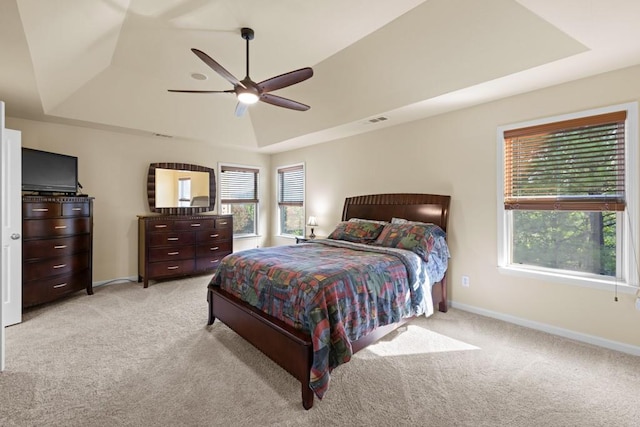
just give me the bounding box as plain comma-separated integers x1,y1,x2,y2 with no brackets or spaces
272,67,640,352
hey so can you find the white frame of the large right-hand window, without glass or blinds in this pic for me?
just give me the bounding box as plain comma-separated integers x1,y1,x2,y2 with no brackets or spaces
496,102,640,293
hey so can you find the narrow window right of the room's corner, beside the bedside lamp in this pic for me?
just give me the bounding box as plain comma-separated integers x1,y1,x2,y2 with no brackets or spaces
278,165,305,236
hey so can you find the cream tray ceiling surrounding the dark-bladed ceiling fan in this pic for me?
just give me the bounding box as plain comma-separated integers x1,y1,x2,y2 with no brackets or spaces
0,0,640,152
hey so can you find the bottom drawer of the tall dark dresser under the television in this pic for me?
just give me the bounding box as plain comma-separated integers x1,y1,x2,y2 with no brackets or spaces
22,269,91,307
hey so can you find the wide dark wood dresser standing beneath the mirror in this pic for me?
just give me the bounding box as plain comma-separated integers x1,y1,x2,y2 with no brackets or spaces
138,215,233,288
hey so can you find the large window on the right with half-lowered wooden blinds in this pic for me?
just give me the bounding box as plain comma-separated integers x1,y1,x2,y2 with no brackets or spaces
498,104,637,290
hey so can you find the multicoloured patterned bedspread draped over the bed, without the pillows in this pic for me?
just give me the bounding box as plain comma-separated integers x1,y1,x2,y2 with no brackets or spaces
211,240,449,398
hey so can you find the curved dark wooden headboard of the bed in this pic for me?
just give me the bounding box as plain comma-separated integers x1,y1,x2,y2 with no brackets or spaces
342,193,451,231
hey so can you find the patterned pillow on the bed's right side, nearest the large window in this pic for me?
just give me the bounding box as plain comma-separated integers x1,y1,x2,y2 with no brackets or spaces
374,222,444,262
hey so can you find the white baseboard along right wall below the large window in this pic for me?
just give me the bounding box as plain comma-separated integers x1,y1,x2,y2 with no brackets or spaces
451,301,640,356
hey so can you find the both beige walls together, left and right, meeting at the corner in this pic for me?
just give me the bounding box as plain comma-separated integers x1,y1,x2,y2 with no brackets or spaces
7,63,640,347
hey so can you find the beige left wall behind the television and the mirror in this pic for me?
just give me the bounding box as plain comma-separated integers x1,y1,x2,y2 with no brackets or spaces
7,117,270,282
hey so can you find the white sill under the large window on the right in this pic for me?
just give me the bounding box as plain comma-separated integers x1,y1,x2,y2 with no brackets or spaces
498,266,639,294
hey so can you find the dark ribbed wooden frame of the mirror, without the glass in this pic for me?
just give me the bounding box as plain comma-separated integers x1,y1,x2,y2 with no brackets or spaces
147,163,216,215
